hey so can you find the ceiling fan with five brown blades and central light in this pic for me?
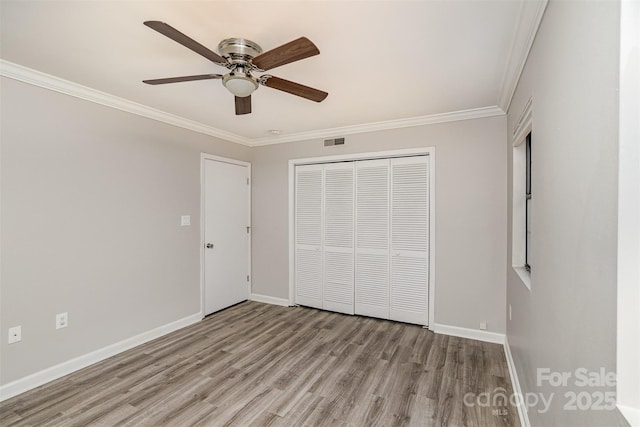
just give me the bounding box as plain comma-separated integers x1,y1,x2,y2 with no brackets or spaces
143,21,328,115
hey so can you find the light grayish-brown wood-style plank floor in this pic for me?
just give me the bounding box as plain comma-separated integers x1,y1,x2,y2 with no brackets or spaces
0,302,519,427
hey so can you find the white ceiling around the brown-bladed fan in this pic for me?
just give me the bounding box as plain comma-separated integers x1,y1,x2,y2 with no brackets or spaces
0,0,533,145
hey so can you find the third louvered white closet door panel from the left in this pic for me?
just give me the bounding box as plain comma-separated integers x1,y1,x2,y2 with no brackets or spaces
355,159,389,319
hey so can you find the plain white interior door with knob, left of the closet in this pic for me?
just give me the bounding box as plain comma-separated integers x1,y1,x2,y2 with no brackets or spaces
203,159,250,315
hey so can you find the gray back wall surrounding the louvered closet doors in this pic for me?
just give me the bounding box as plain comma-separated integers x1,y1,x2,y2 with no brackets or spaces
251,116,506,333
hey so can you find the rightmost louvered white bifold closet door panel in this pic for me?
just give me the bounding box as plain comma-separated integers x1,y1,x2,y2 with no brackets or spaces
389,156,429,325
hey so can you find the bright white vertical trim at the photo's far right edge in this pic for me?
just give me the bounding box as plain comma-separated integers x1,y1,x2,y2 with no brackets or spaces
616,1,640,426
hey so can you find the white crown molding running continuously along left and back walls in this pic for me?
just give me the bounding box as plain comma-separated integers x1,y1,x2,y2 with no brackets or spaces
0,59,505,147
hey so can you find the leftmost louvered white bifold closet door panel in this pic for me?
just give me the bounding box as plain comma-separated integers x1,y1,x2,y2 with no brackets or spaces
294,165,323,308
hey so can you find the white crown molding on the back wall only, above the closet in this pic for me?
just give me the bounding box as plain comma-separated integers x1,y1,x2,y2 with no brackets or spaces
249,105,505,147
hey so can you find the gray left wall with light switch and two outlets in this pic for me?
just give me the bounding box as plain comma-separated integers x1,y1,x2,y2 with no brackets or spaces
0,78,249,384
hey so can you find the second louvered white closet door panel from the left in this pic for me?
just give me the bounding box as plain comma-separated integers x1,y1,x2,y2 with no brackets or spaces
322,162,354,314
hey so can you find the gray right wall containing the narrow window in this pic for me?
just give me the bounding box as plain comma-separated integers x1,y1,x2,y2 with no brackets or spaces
506,1,619,427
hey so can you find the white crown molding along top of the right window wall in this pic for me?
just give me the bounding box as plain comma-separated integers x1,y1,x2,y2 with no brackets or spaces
498,0,548,111
